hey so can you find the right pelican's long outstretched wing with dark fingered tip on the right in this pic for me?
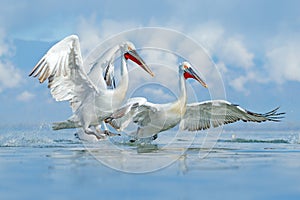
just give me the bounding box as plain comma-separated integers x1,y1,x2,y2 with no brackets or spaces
180,100,284,131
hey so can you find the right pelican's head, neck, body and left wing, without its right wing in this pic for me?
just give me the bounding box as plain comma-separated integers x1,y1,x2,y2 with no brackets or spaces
107,62,207,138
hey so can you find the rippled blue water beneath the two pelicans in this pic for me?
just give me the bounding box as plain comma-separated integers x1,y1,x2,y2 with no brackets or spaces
0,125,300,199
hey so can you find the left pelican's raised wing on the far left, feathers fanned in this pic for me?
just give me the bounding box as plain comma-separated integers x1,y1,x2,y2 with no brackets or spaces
29,35,97,111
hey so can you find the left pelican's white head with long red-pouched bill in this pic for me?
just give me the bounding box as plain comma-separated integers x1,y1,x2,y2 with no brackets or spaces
120,41,154,76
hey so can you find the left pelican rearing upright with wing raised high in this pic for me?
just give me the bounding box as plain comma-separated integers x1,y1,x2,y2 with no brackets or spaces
29,35,154,139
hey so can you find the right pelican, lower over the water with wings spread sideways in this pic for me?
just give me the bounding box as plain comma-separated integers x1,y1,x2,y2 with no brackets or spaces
106,62,284,139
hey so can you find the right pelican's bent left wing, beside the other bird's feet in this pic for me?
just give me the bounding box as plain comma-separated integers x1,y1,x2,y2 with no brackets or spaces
107,97,157,130
